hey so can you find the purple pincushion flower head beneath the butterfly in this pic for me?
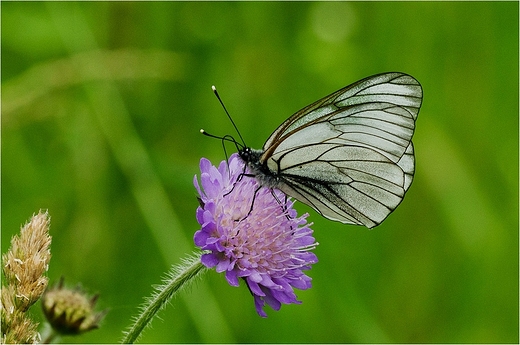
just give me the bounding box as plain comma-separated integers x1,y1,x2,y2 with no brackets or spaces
194,154,318,317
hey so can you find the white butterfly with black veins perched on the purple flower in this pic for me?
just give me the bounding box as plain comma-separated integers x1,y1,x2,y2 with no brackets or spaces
201,72,423,228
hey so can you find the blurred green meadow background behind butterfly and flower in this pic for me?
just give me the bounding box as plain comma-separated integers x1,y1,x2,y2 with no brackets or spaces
1,2,519,343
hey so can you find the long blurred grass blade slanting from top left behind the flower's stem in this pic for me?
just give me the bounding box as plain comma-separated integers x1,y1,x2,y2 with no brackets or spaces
46,3,234,342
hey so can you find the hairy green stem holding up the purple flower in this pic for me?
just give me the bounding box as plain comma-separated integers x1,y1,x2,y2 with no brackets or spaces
121,253,206,344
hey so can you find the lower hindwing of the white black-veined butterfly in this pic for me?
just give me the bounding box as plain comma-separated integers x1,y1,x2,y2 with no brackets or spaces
268,144,406,228
